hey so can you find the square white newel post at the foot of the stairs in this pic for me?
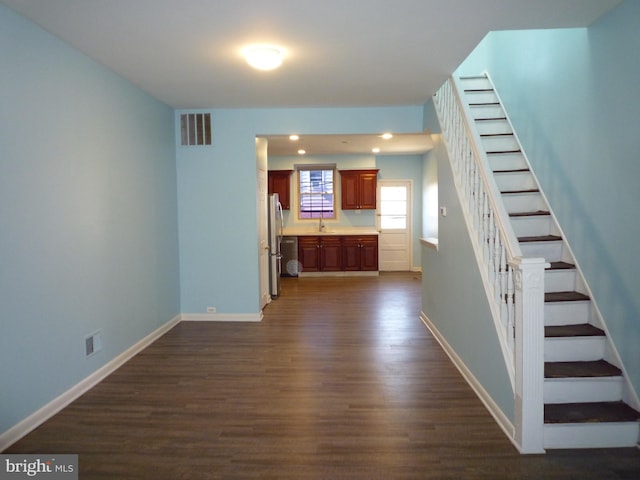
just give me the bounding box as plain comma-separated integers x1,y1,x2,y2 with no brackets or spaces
512,258,547,453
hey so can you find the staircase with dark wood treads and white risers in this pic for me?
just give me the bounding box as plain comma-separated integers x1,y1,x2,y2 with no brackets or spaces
458,76,640,449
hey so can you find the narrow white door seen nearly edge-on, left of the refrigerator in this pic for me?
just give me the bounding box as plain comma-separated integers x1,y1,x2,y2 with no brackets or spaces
256,138,271,309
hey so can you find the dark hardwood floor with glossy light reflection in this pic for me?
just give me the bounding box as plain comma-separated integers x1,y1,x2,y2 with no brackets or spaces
5,273,640,480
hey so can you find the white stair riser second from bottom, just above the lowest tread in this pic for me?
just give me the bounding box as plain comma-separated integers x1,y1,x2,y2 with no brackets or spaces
544,377,623,403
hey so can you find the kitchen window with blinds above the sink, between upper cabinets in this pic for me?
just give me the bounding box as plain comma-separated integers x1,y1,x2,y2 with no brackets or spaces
298,166,336,218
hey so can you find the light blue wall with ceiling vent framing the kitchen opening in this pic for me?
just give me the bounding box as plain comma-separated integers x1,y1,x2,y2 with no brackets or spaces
176,106,423,314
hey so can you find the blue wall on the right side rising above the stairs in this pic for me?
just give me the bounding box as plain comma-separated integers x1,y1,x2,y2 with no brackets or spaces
459,0,640,398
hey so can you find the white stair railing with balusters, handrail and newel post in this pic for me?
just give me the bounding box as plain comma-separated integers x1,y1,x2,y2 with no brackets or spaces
434,77,546,453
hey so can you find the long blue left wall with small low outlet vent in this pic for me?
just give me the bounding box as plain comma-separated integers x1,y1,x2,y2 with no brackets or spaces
0,5,180,433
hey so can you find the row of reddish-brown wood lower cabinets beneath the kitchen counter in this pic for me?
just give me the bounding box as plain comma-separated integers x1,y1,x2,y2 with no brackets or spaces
298,235,378,273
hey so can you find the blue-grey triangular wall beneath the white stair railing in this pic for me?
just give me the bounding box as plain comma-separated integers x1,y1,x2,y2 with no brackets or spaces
422,135,514,422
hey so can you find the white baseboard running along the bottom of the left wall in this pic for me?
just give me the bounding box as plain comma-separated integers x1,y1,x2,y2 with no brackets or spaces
0,315,180,452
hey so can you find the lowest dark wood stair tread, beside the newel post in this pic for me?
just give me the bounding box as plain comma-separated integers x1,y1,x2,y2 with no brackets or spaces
544,402,640,423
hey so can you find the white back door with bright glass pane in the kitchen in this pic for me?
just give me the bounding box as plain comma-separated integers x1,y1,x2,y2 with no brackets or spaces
377,180,411,271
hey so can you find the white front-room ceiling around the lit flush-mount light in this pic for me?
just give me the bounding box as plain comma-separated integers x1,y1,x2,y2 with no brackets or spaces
0,0,620,108
